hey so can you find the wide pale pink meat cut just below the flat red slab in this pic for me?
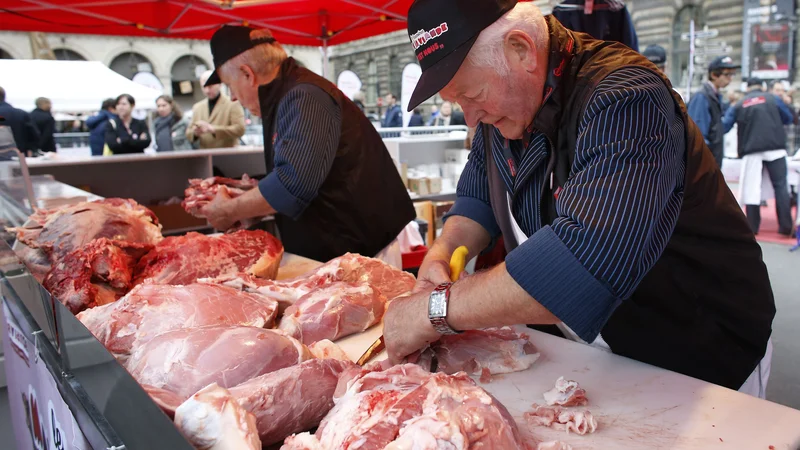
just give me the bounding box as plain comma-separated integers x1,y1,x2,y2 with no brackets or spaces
77,284,278,359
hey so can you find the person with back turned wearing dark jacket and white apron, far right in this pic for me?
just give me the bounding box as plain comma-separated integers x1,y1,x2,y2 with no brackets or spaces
722,77,794,236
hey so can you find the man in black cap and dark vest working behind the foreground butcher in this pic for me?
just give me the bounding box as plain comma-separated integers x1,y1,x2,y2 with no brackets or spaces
201,26,416,264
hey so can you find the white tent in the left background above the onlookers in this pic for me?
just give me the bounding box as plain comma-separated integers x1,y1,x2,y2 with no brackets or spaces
0,59,161,112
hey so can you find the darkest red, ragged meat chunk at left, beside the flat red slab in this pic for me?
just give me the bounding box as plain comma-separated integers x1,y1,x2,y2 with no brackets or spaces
43,238,153,314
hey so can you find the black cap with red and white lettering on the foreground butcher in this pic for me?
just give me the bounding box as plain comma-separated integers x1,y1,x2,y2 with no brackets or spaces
408,0,517,111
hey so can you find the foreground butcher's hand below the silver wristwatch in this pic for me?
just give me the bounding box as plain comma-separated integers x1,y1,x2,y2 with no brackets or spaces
383,288,441,364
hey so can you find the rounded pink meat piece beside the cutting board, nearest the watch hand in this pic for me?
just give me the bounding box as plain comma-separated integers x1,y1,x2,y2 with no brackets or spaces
279,282,386,345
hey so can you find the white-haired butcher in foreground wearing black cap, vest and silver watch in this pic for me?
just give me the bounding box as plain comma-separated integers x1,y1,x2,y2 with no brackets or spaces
384,0,775,395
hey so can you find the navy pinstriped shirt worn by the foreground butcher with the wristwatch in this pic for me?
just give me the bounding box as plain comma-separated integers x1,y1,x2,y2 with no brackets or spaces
450,67,686,342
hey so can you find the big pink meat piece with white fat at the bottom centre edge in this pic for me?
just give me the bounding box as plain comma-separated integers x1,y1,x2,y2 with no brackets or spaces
282,364,526,450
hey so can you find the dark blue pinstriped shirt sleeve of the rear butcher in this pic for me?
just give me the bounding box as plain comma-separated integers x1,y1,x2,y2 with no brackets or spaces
258,84,342,219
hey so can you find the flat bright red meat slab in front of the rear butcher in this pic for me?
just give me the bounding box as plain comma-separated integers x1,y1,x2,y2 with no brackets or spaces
134,230,283,284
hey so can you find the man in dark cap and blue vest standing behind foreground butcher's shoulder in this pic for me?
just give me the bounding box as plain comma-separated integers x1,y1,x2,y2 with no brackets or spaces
686,56,740,167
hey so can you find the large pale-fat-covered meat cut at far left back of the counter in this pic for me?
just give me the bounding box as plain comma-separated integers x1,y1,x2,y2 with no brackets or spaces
9,198,162,279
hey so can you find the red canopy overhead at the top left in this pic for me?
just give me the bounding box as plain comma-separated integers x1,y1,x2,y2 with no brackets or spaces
0,0,411,46
